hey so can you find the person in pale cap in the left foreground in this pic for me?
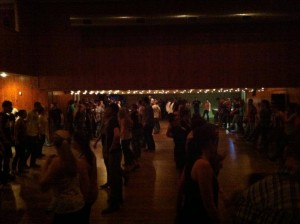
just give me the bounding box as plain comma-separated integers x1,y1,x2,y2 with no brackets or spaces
40,130,85,224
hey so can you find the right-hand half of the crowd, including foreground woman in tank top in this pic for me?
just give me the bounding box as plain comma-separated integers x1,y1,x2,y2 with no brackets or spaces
166,99,300,224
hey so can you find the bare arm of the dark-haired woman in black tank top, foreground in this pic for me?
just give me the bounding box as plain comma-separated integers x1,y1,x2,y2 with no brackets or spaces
192,159,219,223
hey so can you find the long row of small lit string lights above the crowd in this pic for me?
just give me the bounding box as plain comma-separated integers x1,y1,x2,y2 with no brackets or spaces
70,87,265,95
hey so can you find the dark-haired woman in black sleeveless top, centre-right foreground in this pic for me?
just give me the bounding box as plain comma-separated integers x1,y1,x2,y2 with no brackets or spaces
176,123,219,224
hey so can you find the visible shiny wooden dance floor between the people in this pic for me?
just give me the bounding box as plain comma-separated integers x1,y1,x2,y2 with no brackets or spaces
0,122,278,224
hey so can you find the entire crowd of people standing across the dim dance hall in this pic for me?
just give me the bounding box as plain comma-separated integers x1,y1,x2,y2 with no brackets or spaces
0,97,300,223
